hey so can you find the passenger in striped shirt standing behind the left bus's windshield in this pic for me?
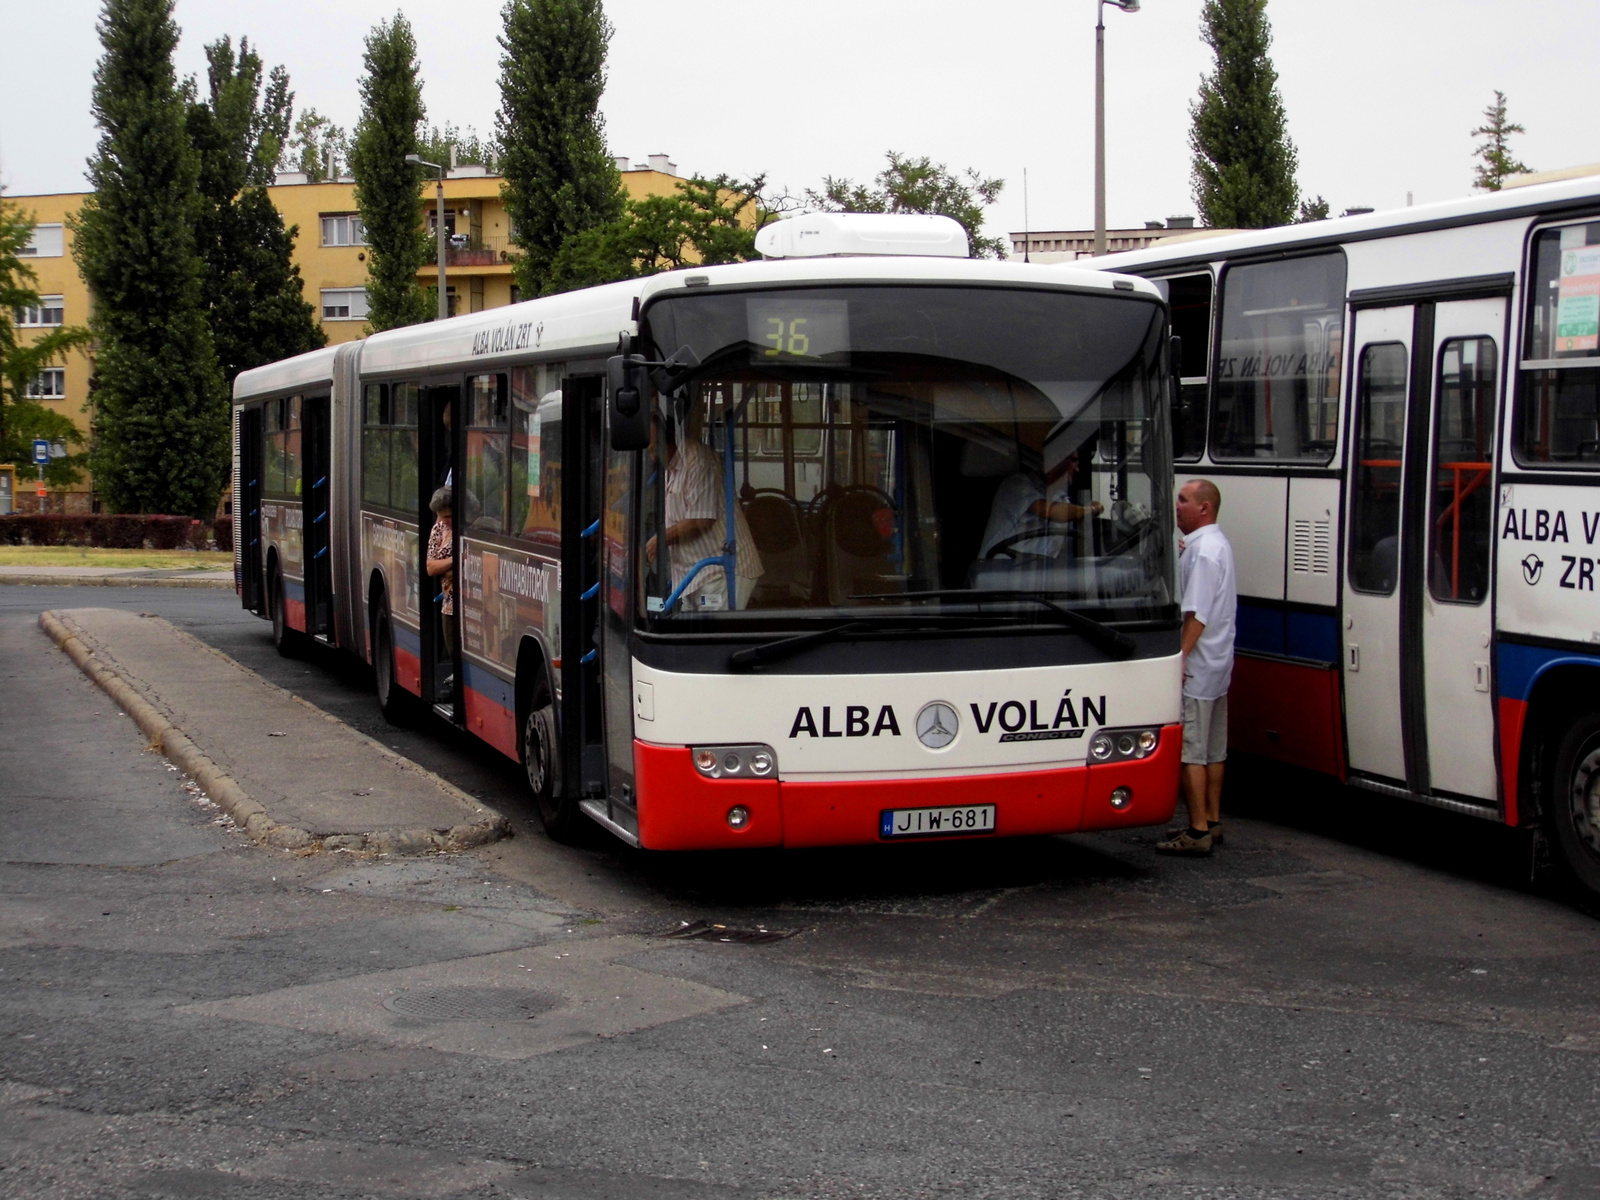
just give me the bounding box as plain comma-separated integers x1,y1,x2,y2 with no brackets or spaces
645,418,763,613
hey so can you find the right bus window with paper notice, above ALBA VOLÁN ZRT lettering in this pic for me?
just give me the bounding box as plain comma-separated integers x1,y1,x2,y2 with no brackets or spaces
1514,222,1600,469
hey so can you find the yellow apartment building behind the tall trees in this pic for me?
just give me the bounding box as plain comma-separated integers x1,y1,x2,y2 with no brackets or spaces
0,154,678,514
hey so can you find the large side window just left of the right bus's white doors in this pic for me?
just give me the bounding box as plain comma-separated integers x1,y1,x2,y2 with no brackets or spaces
1211,254,1344,462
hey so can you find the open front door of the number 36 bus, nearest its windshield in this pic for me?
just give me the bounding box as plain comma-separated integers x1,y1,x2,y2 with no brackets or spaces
560,376,608,800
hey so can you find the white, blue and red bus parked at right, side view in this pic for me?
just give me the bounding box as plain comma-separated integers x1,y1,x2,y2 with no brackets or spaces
1094,176,1600,891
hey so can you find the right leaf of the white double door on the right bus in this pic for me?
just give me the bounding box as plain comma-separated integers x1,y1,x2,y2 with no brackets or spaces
1420,298,1506,805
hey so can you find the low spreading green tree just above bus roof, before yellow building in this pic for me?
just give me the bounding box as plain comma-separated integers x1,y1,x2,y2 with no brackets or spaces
546,174,773,293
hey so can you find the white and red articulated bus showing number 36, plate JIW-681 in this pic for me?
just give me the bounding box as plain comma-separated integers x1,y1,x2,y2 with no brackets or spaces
234,214,1181,850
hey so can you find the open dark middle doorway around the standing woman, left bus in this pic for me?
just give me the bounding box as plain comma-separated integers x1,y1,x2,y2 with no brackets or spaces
414,382,469,725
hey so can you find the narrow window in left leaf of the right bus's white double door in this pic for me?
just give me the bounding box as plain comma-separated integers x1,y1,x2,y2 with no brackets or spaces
1350,342,1406,595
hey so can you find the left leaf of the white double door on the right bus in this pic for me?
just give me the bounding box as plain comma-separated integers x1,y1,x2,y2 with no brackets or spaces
1344,306,1414,786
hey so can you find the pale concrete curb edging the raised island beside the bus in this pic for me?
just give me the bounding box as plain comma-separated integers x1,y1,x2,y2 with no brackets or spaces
38,613,510,854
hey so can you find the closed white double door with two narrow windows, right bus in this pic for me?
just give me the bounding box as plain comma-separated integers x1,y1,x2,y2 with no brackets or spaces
1342,299,1506,806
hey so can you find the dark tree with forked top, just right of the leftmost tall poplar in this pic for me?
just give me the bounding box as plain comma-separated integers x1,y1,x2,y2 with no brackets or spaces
186,37,328,384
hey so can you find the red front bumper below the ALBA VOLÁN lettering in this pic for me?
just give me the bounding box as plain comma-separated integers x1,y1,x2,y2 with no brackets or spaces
634,725,1182,850
